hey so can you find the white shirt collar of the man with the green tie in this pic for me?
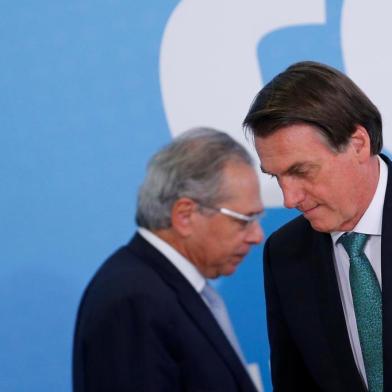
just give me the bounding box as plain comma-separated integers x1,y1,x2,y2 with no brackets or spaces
331,156,388,244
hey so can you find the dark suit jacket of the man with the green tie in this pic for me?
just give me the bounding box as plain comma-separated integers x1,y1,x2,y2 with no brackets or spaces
264,157,392,392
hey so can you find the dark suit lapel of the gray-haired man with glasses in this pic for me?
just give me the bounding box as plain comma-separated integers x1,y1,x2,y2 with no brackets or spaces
130,234,253,390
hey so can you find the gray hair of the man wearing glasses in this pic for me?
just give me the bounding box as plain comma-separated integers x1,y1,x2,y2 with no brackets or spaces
136,128,253,230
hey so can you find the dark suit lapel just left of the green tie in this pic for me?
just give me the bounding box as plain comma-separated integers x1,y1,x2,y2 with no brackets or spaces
312,232,365,391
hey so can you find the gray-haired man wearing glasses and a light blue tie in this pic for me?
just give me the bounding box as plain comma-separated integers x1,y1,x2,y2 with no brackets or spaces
73,128,263,392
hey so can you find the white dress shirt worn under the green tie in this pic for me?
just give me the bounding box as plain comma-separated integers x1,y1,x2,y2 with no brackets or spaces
331,157,388,385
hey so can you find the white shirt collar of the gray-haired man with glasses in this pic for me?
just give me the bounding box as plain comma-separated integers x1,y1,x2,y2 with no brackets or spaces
138,227,206,294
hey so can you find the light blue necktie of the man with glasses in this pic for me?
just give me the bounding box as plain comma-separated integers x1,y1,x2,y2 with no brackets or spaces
201,283,245,364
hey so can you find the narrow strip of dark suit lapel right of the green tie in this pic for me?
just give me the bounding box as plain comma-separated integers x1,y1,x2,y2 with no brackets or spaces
381,155,392,391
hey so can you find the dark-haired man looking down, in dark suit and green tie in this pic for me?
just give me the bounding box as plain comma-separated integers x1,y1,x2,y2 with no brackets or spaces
244,62,392,392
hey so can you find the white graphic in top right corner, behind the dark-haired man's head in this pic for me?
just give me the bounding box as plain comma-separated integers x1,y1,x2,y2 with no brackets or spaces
342,0,392,151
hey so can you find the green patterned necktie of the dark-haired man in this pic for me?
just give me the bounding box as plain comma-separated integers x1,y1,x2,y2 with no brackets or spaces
339,233,383,392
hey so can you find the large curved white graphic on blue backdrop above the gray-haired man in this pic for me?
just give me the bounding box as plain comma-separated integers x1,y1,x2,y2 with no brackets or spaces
160,0,325,207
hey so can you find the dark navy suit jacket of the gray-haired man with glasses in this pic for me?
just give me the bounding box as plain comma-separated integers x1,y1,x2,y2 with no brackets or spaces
73,234,256,392
